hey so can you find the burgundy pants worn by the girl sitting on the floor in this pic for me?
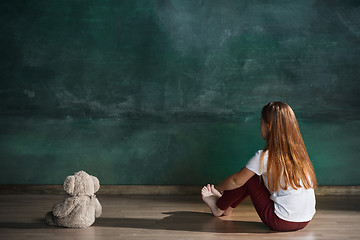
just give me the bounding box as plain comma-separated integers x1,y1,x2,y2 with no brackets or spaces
216,175,309,231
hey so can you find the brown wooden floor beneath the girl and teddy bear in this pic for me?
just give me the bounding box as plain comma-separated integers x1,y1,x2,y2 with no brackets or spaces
0,194,360,240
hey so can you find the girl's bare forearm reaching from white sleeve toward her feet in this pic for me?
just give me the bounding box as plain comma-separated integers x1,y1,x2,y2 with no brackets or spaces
216,167,255,192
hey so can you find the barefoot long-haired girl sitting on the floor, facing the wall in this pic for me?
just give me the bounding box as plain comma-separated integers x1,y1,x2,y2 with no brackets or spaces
201,102,317,231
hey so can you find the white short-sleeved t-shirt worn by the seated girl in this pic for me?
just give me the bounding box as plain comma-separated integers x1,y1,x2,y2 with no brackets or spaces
246,150,316,222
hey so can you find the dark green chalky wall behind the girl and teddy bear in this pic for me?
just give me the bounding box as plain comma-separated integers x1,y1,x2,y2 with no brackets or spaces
0,0,360,185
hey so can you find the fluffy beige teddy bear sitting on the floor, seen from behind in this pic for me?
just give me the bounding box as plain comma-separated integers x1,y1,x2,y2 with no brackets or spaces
45,171,102,228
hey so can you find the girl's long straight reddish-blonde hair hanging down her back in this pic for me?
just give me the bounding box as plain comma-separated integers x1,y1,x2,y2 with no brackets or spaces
261,102,317,191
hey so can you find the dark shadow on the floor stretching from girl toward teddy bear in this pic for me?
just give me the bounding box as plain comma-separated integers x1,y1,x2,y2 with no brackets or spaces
94,211,272,233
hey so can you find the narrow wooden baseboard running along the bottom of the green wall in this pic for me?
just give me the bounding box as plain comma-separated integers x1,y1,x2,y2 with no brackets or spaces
0,184,360,195
